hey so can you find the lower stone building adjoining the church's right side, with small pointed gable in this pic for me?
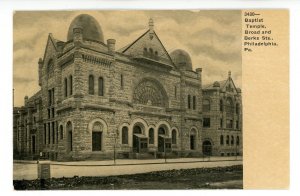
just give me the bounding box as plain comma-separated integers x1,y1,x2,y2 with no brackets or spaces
202,72,243,156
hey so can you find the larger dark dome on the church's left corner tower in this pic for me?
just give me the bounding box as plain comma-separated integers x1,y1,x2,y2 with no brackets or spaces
68,14,104,43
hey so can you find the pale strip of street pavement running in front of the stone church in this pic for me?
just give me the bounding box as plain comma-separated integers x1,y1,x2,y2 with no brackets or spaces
13,157,243,180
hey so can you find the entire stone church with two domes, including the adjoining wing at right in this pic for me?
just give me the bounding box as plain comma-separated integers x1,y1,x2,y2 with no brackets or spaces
13,14,242,161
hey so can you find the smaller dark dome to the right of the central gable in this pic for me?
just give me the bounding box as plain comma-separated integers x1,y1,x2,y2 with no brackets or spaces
170,49,193,71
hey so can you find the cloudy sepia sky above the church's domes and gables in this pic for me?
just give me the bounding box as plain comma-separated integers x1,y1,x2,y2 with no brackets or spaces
13,10,242,106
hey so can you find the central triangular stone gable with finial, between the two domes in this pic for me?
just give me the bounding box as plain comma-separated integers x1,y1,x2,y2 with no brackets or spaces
119,30,173,66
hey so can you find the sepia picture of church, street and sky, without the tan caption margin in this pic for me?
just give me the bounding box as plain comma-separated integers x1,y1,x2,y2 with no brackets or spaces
13,10,244,190
